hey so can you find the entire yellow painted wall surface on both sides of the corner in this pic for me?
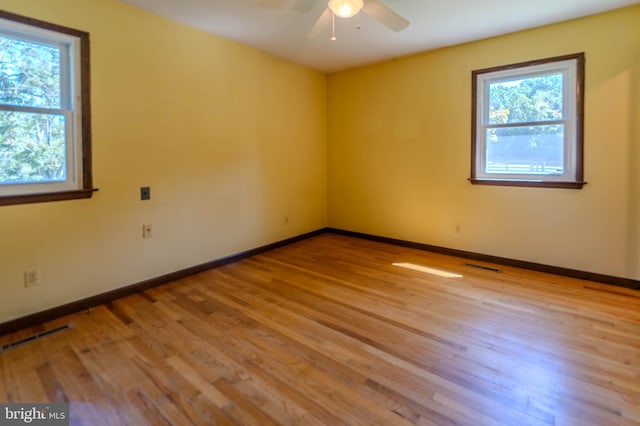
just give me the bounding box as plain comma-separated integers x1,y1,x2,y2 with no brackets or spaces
0,0,640,322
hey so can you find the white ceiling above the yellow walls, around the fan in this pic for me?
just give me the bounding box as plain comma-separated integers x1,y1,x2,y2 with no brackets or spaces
120,0,640,73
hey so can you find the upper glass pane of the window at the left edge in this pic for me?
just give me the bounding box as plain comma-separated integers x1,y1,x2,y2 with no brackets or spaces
0,35,61,108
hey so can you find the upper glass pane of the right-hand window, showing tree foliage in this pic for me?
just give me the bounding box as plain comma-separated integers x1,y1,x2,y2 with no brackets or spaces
488,74,563,124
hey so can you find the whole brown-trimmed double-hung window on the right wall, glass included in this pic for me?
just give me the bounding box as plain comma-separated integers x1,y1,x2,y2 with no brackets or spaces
470,53,585,189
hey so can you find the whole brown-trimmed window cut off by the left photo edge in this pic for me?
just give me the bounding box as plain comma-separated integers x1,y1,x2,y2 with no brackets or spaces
0,11,94,205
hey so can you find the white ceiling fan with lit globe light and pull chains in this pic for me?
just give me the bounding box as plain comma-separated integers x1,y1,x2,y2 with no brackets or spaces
260,0,409,40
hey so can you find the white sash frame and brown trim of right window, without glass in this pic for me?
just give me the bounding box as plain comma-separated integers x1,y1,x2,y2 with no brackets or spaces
470,54,585,188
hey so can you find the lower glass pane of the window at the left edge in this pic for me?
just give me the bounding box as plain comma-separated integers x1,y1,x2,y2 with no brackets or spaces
0,111,67,184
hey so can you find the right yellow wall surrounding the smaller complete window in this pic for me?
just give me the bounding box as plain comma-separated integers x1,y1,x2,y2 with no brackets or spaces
328,6,640,279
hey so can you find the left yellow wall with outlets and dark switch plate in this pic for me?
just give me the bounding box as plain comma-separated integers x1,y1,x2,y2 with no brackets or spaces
0,0,327,322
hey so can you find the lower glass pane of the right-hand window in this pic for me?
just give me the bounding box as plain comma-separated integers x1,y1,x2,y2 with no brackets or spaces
485,125,564,175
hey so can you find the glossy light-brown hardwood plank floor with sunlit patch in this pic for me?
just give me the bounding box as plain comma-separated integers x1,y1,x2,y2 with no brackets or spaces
0,234,640,426
